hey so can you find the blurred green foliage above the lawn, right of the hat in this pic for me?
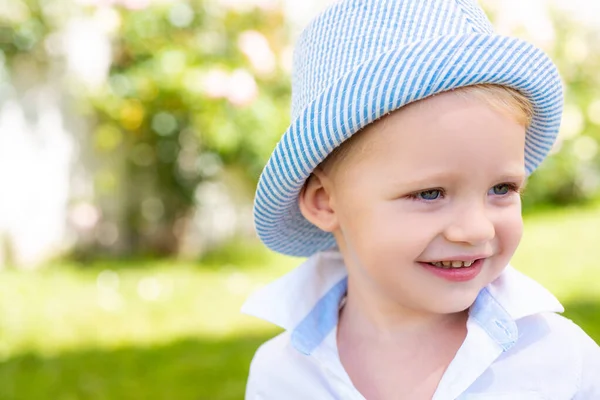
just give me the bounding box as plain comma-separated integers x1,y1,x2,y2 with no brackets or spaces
523,9,600,211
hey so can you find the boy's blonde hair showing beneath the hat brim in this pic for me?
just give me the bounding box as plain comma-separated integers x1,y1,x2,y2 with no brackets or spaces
317,83,534,172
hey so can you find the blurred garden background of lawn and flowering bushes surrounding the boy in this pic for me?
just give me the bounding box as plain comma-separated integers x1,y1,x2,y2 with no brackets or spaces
0,0,600,400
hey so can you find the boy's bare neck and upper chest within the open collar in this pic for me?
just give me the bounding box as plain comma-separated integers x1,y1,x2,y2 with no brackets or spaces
337,280,468,400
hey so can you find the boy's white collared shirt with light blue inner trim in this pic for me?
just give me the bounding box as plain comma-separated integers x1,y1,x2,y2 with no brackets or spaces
242,251,600,400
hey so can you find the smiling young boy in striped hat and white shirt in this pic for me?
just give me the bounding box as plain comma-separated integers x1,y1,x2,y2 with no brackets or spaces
244,0,600,400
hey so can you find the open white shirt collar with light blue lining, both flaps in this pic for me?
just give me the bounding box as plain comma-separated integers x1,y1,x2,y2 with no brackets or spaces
242,250,564,354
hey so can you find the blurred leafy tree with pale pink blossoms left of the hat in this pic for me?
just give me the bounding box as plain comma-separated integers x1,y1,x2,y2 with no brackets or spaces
85,1,289,254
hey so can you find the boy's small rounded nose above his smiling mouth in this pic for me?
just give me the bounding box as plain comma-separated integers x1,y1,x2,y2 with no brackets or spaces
444,206,496,246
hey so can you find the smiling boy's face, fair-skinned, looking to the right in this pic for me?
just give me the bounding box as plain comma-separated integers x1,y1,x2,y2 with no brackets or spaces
323,93,525,313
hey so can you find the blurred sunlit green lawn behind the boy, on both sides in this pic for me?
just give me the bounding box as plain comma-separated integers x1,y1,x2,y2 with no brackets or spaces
0,208,600,400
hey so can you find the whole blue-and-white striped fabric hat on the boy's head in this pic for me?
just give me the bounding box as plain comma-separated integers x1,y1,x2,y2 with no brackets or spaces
254,0,563,256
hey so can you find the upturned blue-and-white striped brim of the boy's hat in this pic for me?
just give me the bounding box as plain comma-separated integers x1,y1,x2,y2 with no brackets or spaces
254,34,563,257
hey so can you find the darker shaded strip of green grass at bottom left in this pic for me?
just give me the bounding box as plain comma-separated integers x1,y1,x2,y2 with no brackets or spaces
0,334,270,400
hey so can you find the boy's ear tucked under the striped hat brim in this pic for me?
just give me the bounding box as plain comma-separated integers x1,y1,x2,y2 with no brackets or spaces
298,169,338,232
